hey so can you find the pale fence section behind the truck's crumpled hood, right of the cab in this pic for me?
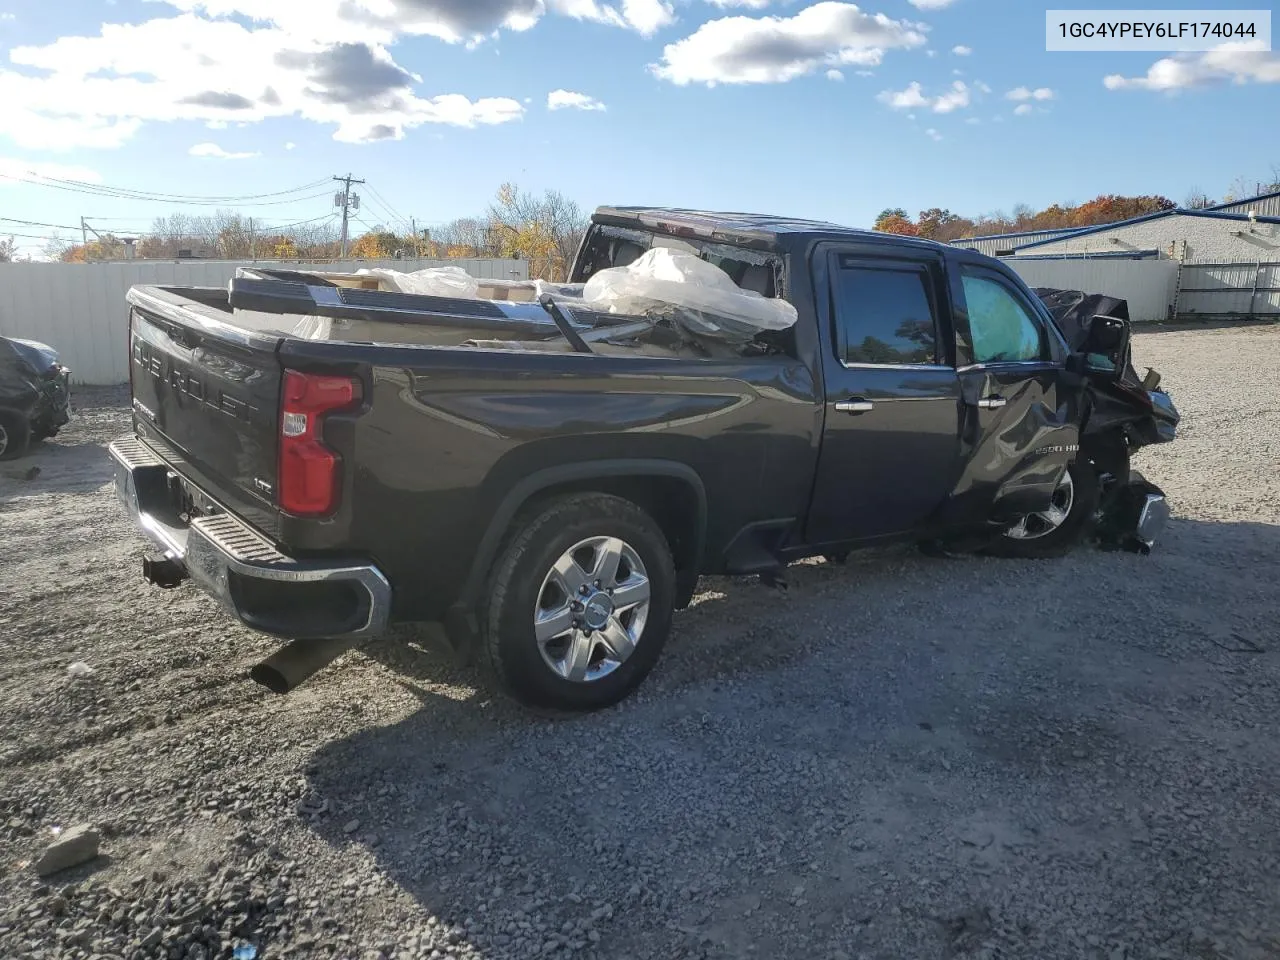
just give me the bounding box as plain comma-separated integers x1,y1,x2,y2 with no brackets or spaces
1004,257,1178,323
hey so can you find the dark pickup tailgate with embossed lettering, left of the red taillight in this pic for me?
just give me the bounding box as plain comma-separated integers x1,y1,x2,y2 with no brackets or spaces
129,287,282,534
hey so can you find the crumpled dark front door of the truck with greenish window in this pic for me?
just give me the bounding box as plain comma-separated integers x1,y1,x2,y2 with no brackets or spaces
946,260,1080,522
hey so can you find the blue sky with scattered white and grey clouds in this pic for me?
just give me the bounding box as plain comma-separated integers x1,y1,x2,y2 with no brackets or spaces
0,0,1280,257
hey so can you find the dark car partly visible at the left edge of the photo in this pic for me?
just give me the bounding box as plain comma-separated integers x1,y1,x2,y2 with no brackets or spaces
0,337,70,460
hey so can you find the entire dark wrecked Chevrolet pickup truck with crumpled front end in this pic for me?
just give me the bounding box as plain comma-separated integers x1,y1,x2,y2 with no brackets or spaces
111,207,1176,710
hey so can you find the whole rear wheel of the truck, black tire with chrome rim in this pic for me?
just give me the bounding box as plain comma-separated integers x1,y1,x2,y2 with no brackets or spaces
485,494,676,710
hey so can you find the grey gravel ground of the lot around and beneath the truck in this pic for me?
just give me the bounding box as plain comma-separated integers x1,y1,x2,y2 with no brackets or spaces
0,326,1280,960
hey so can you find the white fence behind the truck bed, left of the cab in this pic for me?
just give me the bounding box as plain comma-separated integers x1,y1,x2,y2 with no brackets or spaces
0,260,529,384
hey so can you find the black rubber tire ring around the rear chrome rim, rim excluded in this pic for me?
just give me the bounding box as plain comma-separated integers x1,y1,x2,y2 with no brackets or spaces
481,493,676,712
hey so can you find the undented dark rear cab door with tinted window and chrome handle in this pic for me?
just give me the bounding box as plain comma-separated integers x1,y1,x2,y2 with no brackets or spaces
806,243,960,544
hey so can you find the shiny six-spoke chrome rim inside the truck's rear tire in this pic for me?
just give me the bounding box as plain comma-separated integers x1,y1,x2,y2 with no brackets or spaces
534,536,650,684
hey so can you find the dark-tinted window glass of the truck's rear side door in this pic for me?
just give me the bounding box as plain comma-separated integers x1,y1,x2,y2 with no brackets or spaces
832,260,941,365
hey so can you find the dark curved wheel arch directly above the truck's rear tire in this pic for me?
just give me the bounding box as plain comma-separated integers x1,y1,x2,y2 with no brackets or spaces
508,475,703,577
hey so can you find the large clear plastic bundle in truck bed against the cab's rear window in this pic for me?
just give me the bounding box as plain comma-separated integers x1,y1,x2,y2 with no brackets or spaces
582,247,797,340
